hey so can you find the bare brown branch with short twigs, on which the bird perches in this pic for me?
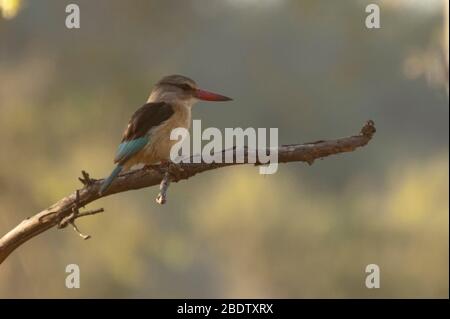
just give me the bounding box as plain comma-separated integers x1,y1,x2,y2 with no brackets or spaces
0,121,375,263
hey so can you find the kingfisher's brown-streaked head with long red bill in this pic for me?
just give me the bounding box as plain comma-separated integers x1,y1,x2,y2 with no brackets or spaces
149,75,231,106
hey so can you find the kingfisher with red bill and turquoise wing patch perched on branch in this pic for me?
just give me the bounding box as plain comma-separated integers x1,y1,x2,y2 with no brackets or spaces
99,74,232,195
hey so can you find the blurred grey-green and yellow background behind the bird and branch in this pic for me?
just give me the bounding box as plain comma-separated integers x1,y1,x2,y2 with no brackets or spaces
0,0,449,298
